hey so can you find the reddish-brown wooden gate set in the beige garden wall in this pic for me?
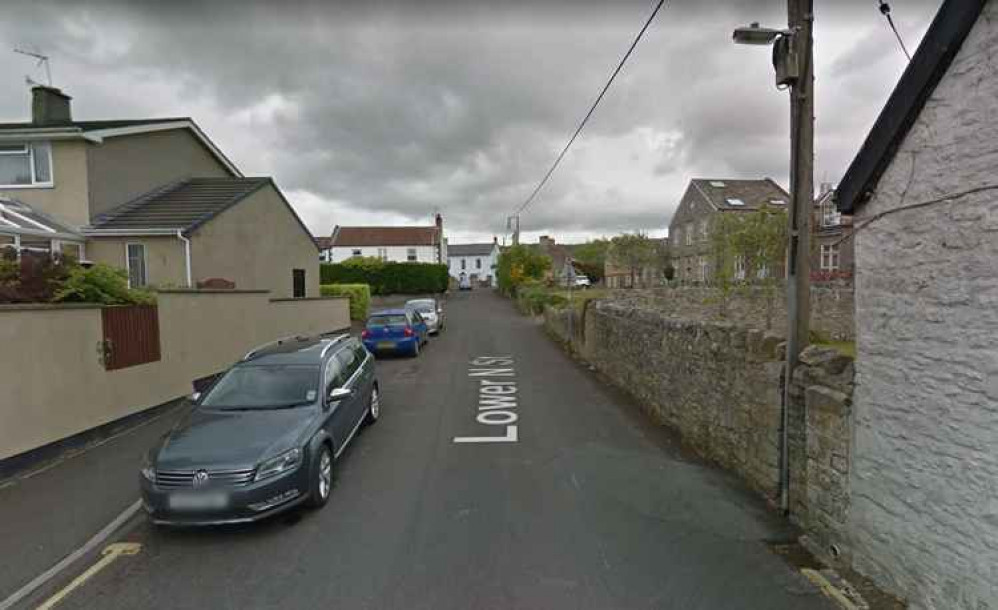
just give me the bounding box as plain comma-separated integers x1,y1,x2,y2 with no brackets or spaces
99,305,160,371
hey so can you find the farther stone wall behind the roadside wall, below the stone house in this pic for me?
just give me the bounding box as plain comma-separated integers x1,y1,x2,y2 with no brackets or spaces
610,282,855,341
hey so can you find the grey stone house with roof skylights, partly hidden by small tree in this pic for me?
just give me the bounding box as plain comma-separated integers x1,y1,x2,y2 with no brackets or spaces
669,178,790,282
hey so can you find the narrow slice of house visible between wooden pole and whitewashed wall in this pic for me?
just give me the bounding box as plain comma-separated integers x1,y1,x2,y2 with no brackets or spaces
811,184,853,281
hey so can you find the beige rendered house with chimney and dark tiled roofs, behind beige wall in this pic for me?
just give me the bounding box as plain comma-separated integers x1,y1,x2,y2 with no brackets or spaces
0,86,319,297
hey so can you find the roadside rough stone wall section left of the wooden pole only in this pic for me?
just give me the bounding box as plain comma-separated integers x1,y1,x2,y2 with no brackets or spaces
545,300,783,498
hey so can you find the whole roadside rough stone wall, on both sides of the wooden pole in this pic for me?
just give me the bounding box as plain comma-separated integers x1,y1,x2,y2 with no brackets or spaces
544,299,853,576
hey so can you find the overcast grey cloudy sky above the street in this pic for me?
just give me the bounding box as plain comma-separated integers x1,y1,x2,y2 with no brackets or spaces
0,0,941,243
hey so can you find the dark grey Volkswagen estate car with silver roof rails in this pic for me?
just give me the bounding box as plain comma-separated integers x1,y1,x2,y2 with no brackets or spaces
145,335,381,525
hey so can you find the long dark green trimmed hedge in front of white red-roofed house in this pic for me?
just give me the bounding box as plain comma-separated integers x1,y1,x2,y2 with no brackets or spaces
320,262,448,295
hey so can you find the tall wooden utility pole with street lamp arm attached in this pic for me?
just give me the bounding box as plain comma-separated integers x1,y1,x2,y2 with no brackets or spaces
732,0,814,512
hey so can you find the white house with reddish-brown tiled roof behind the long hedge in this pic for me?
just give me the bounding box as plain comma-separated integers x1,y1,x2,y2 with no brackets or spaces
324,214,447,264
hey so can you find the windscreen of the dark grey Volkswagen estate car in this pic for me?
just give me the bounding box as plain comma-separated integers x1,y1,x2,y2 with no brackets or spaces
201,365,319,409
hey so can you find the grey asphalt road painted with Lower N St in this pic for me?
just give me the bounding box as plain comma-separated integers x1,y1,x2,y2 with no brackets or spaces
25,291,833,610
